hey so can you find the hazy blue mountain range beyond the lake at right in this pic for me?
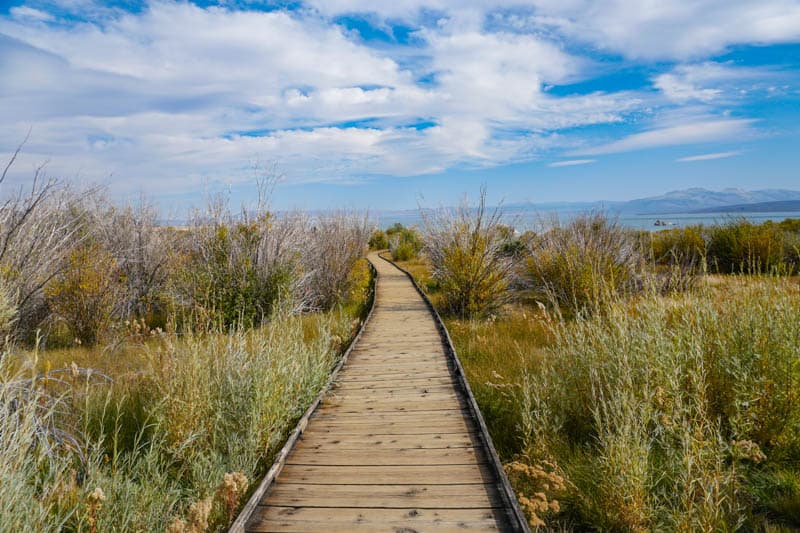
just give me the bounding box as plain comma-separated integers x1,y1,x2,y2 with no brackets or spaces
507,187,800,215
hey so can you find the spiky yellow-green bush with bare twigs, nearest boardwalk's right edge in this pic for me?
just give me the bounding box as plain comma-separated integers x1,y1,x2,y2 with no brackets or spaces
421,189,513,317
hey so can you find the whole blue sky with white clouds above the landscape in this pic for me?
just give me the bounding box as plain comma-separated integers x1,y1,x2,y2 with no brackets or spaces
0,0,800,209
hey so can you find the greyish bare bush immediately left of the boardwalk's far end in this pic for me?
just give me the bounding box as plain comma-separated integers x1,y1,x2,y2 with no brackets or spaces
305,211,370,309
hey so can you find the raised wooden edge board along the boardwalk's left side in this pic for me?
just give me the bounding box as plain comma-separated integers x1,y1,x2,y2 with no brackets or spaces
228,261,378,533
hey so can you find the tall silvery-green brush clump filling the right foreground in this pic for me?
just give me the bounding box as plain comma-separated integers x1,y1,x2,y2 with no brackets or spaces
520,278,800,531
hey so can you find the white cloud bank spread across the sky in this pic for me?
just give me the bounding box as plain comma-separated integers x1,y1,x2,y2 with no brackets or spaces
0,0,800,193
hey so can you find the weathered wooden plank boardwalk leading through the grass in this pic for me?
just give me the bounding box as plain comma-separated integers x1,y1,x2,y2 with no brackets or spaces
232,254,527,532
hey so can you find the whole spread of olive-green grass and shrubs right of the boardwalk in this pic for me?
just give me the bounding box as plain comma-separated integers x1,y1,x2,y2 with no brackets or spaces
401,215,800,531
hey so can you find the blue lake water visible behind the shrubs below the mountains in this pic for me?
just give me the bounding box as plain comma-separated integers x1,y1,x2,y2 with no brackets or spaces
378,208,800,231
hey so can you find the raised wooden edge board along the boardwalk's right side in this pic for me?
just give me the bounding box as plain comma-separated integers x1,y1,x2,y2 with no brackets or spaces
379,254,531,533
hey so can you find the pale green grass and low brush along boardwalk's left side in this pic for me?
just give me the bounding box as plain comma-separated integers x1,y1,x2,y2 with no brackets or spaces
0,314,352,531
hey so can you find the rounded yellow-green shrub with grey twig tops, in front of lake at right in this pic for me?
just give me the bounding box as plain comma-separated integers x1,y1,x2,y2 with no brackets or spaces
525,213,644,312
